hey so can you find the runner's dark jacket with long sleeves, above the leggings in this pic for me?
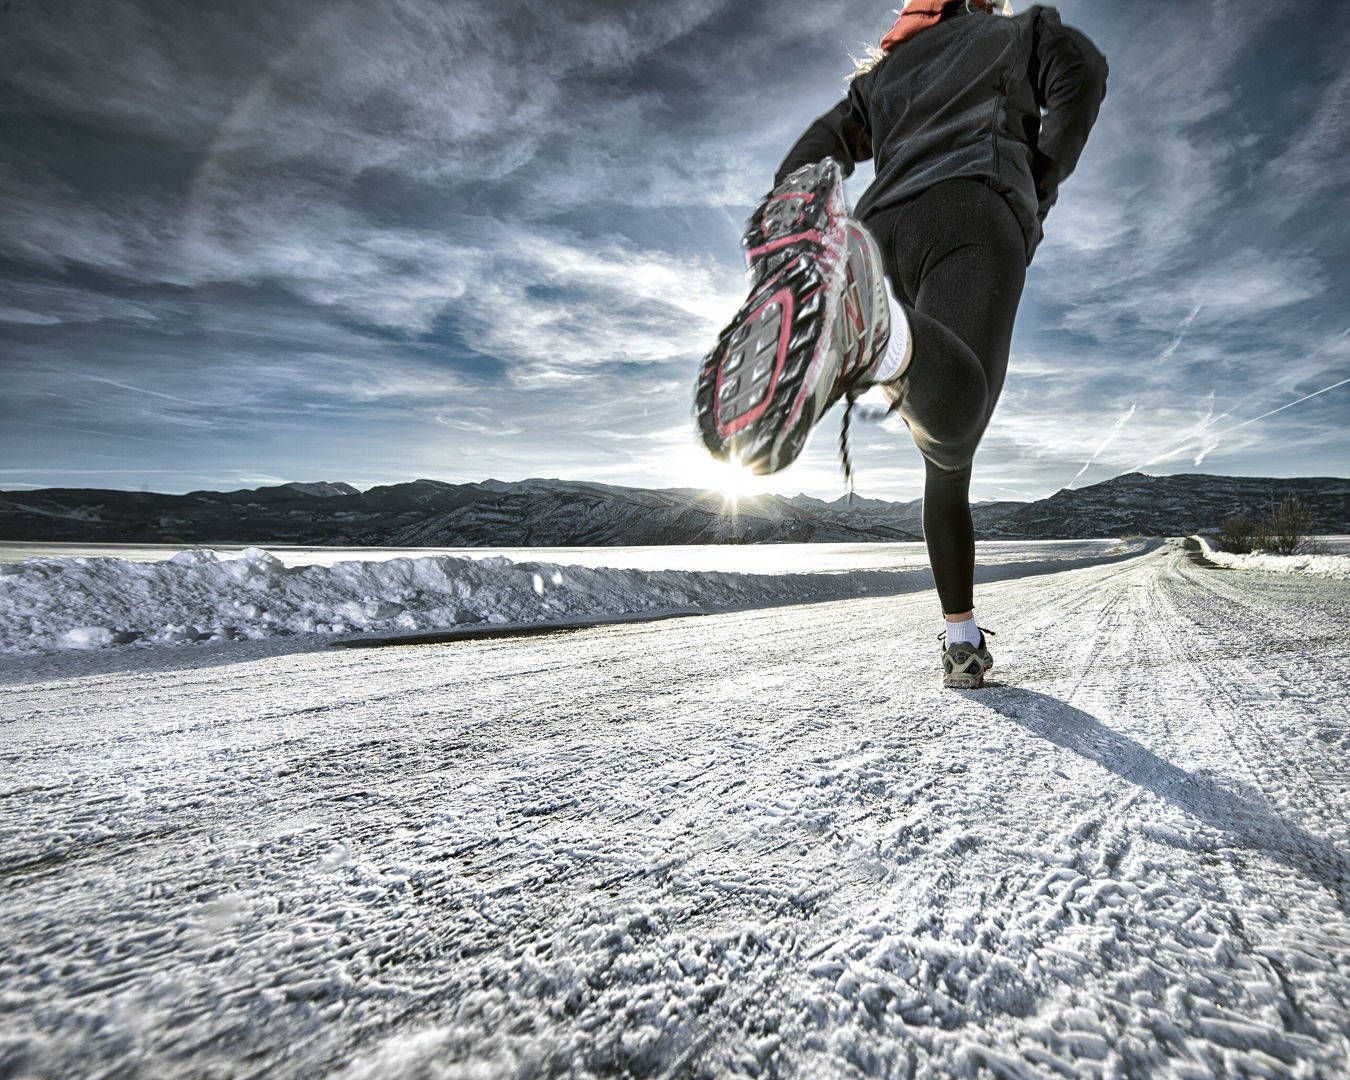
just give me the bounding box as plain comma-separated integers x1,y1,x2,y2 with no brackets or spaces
775,0,1107,262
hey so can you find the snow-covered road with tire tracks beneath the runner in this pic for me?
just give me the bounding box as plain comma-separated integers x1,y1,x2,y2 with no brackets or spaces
0,541,1350,1079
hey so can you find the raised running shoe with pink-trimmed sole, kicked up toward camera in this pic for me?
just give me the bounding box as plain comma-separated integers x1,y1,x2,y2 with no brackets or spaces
694,158,890,473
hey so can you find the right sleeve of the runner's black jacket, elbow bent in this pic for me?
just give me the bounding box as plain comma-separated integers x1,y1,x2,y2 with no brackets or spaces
1030,8,1108,221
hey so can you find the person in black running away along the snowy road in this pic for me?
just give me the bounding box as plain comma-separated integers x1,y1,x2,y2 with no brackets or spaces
695,0,1107,687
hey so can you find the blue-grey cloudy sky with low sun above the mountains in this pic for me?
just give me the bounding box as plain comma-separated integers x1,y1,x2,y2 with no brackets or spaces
0,0,1350,500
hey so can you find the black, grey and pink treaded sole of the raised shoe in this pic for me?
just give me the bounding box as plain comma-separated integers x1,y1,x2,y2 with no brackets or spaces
694,161,845,473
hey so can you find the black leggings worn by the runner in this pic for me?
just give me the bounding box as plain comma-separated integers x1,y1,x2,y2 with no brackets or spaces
865,180,1026,614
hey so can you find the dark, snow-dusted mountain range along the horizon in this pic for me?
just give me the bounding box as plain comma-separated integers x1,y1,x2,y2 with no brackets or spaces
0,473,1350,547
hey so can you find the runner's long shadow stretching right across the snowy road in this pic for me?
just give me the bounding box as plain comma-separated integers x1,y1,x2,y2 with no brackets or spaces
963,684,1350,911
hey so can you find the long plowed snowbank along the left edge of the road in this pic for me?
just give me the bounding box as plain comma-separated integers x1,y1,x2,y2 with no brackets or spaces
0,541,1145,652
